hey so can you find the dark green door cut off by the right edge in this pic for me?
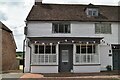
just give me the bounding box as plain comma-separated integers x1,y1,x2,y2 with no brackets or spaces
113,49,120,70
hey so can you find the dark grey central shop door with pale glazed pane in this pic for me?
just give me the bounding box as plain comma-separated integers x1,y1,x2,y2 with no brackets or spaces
59,45,73,72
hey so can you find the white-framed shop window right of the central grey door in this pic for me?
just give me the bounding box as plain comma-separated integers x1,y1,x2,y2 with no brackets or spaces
75,44,99,64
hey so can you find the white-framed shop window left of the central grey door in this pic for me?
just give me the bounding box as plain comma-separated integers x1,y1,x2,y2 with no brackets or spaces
32,44,57,65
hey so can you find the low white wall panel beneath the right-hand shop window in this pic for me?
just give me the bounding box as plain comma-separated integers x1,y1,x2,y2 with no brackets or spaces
73,65,100,73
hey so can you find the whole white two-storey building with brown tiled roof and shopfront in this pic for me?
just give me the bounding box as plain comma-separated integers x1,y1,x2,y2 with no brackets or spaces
24,0,120,73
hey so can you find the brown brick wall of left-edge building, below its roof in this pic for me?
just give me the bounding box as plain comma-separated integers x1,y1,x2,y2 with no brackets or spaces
2,30,18,71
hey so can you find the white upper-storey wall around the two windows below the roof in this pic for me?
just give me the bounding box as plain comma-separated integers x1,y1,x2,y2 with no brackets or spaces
27,21,118,44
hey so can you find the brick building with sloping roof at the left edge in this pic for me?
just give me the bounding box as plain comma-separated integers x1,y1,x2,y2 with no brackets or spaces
0,22,18,71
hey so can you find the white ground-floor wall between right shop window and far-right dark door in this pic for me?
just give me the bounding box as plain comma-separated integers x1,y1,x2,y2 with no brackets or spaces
100,45,112,71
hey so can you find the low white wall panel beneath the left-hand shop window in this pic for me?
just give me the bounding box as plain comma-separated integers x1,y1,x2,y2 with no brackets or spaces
31,66,58,73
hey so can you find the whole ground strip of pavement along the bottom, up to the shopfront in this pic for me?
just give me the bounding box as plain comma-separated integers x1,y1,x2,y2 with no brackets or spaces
0,71,120,80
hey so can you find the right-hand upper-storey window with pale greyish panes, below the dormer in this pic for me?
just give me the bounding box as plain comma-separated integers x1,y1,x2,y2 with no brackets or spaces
95,23,112,34
